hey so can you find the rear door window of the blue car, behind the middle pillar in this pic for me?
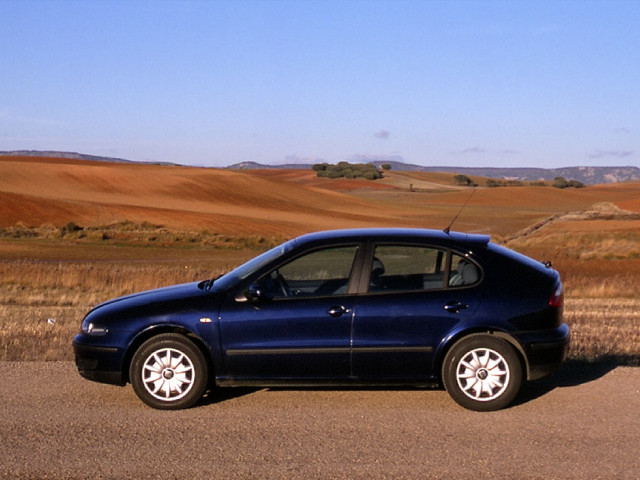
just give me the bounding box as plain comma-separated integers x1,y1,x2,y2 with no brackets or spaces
369,245,447,293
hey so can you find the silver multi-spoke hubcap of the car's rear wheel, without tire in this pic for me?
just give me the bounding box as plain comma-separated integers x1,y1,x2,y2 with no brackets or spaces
456,348,510,402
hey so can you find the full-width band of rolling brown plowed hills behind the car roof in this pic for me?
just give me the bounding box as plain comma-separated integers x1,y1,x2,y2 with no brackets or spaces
0,156,640,237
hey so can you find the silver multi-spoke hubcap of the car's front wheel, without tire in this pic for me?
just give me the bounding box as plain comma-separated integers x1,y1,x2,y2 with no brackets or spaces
142,348,195,402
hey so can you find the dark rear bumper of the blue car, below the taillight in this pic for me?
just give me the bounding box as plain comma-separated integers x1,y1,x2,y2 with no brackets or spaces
518,323,571,380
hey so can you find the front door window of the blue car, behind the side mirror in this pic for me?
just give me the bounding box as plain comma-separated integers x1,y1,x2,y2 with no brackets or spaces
259,245,358,298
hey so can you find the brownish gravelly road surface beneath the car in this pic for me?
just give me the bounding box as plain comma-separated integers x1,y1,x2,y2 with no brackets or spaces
0,362,640,479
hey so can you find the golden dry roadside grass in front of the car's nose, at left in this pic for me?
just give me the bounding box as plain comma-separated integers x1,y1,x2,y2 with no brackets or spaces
0,261,245,360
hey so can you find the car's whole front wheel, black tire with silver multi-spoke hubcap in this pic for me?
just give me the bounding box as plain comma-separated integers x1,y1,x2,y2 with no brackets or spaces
129,333,208,410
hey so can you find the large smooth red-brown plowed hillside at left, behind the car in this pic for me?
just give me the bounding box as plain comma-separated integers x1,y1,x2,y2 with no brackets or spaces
0,158,410,236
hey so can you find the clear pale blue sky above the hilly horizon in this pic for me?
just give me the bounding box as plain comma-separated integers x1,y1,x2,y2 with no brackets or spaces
0,0,640,167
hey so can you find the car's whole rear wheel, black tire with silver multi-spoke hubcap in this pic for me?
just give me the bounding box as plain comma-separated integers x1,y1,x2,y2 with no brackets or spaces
442,335,523,412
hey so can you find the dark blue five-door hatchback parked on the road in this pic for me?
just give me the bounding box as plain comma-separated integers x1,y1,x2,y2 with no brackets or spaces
73,229,569,410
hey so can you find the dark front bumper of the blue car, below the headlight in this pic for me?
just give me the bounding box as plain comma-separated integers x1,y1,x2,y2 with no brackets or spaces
73,333,126,385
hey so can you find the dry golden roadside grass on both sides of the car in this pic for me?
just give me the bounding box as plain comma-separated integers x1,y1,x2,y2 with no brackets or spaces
0,238,640,365
